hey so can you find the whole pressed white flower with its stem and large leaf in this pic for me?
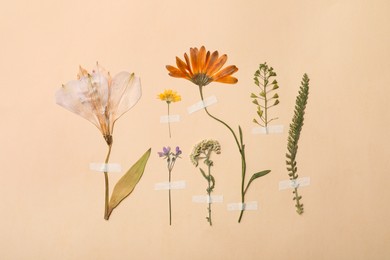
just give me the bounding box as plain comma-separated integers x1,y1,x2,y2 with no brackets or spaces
56,64,151,220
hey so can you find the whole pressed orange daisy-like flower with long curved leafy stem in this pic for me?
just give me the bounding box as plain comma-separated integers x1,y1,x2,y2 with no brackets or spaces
166,46,270,222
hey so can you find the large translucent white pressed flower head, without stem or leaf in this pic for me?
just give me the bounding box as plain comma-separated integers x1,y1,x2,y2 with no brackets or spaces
56,64,141,145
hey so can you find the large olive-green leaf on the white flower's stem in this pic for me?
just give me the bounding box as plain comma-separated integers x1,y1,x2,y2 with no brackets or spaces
108,148,152,216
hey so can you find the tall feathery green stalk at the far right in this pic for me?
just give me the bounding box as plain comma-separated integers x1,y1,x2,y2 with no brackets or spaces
286,73,310,215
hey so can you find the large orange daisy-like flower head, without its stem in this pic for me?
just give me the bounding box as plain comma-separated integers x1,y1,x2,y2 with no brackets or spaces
166,46,238,87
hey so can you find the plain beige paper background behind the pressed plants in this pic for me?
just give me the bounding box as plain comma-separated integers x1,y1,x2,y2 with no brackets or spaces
0,0,390,259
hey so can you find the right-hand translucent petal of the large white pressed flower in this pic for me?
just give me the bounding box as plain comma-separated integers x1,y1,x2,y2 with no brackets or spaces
110,72,141,122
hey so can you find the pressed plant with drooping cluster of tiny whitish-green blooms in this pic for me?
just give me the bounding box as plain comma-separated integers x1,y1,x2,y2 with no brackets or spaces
190,140,221,226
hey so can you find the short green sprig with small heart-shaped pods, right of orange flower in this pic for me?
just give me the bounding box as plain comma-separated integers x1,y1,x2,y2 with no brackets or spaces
251,62,279,127
